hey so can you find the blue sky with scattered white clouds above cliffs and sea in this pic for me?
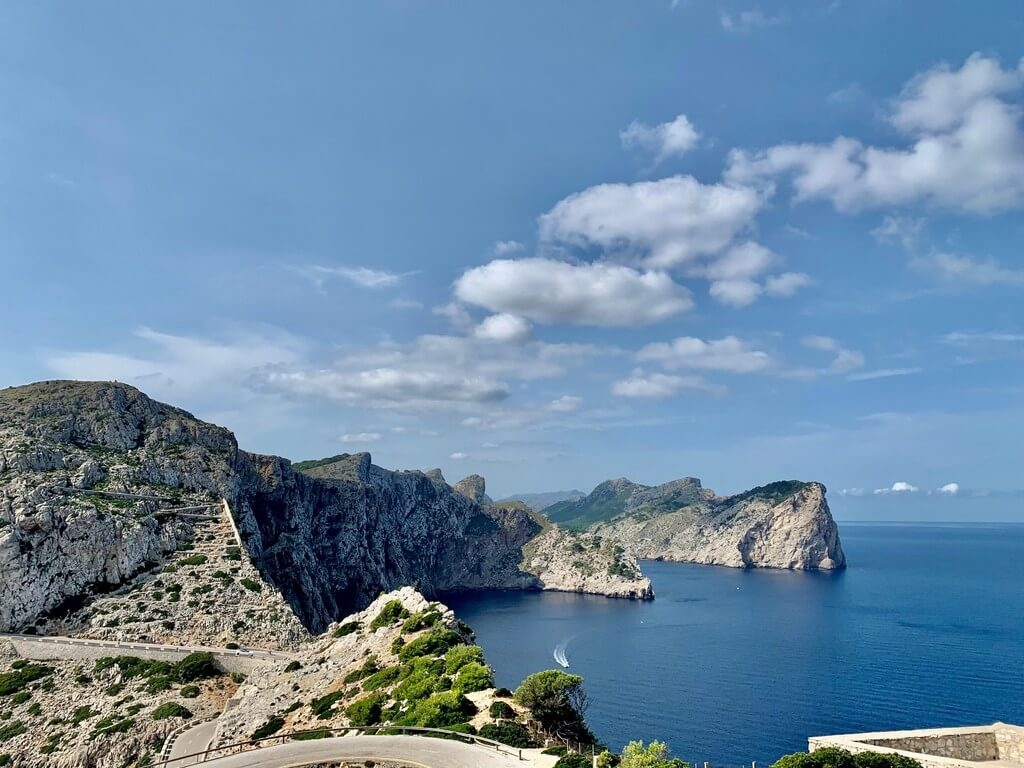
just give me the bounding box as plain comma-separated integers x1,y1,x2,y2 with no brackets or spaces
0,0,1024,520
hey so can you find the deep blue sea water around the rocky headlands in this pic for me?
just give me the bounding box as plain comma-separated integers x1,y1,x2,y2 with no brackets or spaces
445,523,1024,766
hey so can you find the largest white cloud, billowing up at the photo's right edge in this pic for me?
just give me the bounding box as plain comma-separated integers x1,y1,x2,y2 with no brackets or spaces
725,53,1024,214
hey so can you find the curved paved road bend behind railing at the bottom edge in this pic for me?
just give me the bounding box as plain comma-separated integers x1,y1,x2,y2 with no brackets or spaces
187,736,530,768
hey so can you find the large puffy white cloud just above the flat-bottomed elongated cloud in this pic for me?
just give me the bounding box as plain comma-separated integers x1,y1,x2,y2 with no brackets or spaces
540,176,764,268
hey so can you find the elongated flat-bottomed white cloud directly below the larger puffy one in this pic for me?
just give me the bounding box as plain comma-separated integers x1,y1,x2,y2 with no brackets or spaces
455,258,692,327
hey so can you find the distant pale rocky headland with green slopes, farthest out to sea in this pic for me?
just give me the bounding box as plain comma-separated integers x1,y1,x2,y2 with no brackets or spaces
549,477,846,570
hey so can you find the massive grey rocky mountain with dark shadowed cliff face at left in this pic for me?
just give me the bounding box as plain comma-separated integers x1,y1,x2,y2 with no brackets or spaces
0,382,647,631
